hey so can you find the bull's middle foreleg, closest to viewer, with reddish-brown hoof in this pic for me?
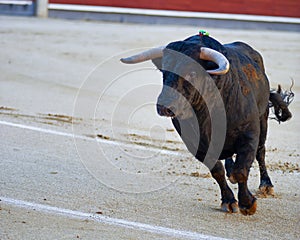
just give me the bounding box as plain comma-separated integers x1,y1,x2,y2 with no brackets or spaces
229,134,258,215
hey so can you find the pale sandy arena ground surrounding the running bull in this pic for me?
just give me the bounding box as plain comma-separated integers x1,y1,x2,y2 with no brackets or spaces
0,16,300,240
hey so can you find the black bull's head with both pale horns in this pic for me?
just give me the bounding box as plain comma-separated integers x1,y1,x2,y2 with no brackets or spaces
121,41,229,119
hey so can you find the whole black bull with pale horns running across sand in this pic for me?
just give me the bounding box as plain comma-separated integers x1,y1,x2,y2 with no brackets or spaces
121,35,291,215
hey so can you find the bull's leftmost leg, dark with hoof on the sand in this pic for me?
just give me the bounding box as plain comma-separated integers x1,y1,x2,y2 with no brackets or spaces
210,160,238,213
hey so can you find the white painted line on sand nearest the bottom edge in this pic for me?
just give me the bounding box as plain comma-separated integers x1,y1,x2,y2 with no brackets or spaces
0,196,230,240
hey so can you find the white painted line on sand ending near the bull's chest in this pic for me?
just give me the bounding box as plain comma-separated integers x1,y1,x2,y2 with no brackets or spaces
0,121,184,156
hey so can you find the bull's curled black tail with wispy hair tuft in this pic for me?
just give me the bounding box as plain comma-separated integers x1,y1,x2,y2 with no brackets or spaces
269,85,294,123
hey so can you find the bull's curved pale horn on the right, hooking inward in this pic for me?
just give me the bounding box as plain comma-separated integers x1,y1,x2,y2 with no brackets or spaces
200,47,229,75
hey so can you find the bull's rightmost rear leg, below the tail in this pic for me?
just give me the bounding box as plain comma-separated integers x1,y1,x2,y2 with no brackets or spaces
256,109,274,195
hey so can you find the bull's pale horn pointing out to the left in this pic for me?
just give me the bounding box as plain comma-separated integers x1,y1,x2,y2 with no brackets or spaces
120,46,165,64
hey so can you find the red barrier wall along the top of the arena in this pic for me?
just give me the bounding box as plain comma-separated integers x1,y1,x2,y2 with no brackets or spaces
49,0,300,18
